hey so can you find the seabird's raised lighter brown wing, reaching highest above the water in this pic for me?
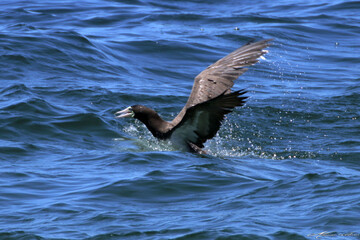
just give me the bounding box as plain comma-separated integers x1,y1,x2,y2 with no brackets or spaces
172,39,272,126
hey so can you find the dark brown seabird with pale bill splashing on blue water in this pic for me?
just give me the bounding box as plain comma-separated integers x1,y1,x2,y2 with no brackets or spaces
115,39,272,153
